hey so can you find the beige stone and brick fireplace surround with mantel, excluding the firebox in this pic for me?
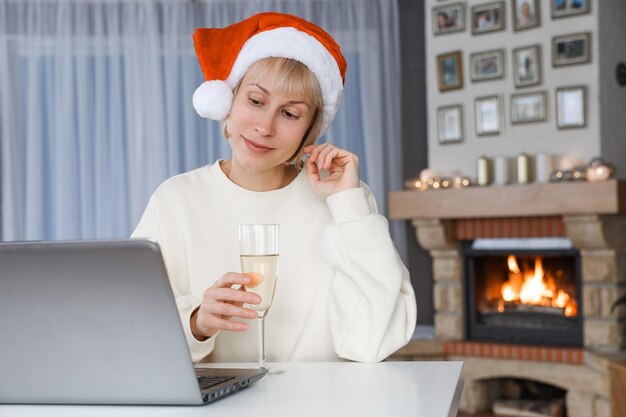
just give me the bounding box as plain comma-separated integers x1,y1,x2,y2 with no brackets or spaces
389,180,626,417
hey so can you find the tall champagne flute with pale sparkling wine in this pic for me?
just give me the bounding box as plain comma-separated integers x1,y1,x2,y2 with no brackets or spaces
239,224,279,369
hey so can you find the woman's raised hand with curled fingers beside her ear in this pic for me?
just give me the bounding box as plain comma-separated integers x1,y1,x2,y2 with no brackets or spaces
303,143,359,198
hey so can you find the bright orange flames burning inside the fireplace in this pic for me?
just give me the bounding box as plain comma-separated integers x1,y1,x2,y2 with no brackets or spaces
499,255,578,317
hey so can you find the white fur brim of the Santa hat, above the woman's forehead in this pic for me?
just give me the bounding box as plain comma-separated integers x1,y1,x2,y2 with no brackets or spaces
224,27,343,136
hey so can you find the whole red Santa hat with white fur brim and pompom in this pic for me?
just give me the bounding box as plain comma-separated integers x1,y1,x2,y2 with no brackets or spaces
193,12,347,136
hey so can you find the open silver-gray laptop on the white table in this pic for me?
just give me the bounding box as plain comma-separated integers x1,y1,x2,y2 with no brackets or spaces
0,239,267,405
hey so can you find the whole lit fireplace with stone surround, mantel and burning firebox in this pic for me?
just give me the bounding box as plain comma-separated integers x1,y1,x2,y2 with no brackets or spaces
389,180,626,417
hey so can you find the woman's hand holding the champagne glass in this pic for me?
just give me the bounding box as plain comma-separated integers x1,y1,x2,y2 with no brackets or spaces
190,272,261,341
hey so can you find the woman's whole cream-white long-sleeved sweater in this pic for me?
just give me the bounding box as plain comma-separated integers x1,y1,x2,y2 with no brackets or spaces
133,163,416,362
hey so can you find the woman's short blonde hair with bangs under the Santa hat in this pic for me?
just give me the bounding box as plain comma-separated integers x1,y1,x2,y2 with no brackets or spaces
222,57,324,169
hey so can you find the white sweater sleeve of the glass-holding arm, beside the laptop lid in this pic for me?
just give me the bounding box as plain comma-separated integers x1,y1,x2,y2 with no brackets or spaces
131,195,218,362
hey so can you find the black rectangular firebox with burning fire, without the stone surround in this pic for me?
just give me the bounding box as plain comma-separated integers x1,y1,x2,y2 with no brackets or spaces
463,239,583,347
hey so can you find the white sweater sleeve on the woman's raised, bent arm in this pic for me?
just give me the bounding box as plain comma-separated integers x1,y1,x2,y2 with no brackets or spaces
323,184,417,362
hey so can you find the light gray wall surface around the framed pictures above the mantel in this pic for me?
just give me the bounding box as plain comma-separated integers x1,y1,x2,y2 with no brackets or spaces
425,0,600,177
